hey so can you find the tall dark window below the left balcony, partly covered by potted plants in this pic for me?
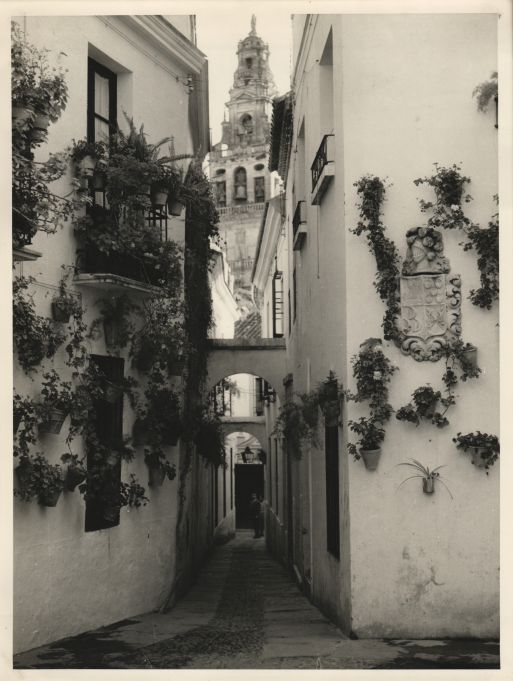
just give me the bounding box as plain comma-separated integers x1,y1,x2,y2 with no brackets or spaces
85,355,125,532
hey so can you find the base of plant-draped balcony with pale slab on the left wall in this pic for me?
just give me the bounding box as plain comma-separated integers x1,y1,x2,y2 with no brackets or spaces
74,246,164,295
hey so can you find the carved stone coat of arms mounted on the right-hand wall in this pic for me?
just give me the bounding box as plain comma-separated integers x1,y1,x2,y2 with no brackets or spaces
398,227,461,362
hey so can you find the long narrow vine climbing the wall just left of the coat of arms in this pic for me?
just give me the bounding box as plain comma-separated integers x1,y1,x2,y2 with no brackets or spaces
352,175,400,340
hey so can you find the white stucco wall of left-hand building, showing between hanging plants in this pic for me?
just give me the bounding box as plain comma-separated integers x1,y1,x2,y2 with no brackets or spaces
14,17,202,652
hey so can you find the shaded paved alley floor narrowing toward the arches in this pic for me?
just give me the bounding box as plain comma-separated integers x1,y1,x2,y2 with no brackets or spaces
14,531,499,669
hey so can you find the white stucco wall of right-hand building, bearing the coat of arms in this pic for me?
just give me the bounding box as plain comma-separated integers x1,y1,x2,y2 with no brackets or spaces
287,15,500,637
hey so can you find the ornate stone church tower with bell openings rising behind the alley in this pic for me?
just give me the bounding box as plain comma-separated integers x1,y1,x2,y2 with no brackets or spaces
209,15,276,326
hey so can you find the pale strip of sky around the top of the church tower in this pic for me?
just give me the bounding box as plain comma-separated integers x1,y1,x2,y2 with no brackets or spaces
196,8,292,144
